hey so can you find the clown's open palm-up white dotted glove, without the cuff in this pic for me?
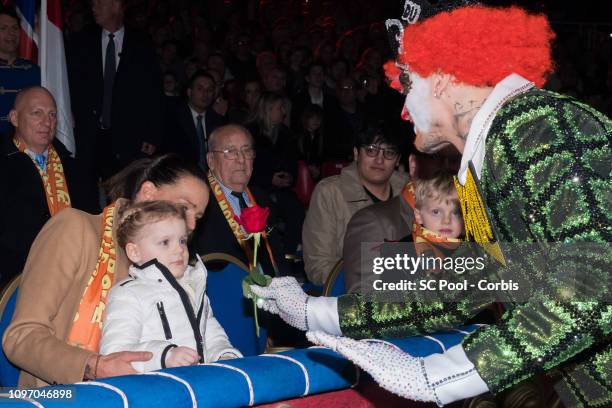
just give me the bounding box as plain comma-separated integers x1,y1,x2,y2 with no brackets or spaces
306,331,441,405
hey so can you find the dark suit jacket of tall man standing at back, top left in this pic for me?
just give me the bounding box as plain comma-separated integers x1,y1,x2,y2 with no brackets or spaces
67,26,163,171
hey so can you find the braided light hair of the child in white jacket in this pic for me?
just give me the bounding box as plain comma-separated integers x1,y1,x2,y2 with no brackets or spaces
117,201,187,248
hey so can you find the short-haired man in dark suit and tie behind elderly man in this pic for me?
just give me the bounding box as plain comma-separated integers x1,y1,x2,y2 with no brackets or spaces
166,71,226,170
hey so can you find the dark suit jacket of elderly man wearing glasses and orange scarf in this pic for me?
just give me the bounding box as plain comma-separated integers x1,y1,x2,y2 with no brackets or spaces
190,187,291,276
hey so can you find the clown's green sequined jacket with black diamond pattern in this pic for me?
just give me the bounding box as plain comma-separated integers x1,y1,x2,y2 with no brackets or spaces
338,89,612,407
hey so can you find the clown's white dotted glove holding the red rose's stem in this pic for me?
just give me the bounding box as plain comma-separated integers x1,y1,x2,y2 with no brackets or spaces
250,276,310,330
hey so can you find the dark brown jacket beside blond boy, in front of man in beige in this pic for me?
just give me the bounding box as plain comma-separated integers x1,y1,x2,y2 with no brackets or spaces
342,194,414,293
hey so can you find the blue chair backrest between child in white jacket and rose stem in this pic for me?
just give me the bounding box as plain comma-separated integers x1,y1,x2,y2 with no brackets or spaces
202,253,267,356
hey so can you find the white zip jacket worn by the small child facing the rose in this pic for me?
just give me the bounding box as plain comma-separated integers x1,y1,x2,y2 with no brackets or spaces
100,257,242,372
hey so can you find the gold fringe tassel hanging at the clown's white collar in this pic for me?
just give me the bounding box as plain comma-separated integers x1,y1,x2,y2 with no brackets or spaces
455,165,506,266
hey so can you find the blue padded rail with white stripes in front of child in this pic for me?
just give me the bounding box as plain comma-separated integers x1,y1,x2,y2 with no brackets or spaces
0,325,478,408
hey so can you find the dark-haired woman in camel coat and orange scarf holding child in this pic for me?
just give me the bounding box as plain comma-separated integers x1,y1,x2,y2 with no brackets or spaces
3,155,209,388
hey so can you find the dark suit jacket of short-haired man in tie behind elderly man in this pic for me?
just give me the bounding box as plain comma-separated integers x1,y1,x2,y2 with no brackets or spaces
164,101,227,163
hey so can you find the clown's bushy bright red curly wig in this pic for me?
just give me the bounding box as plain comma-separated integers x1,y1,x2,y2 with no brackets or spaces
389,6,555,87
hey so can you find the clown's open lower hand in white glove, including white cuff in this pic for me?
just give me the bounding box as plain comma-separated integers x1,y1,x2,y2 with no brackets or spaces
306,331,488,406
